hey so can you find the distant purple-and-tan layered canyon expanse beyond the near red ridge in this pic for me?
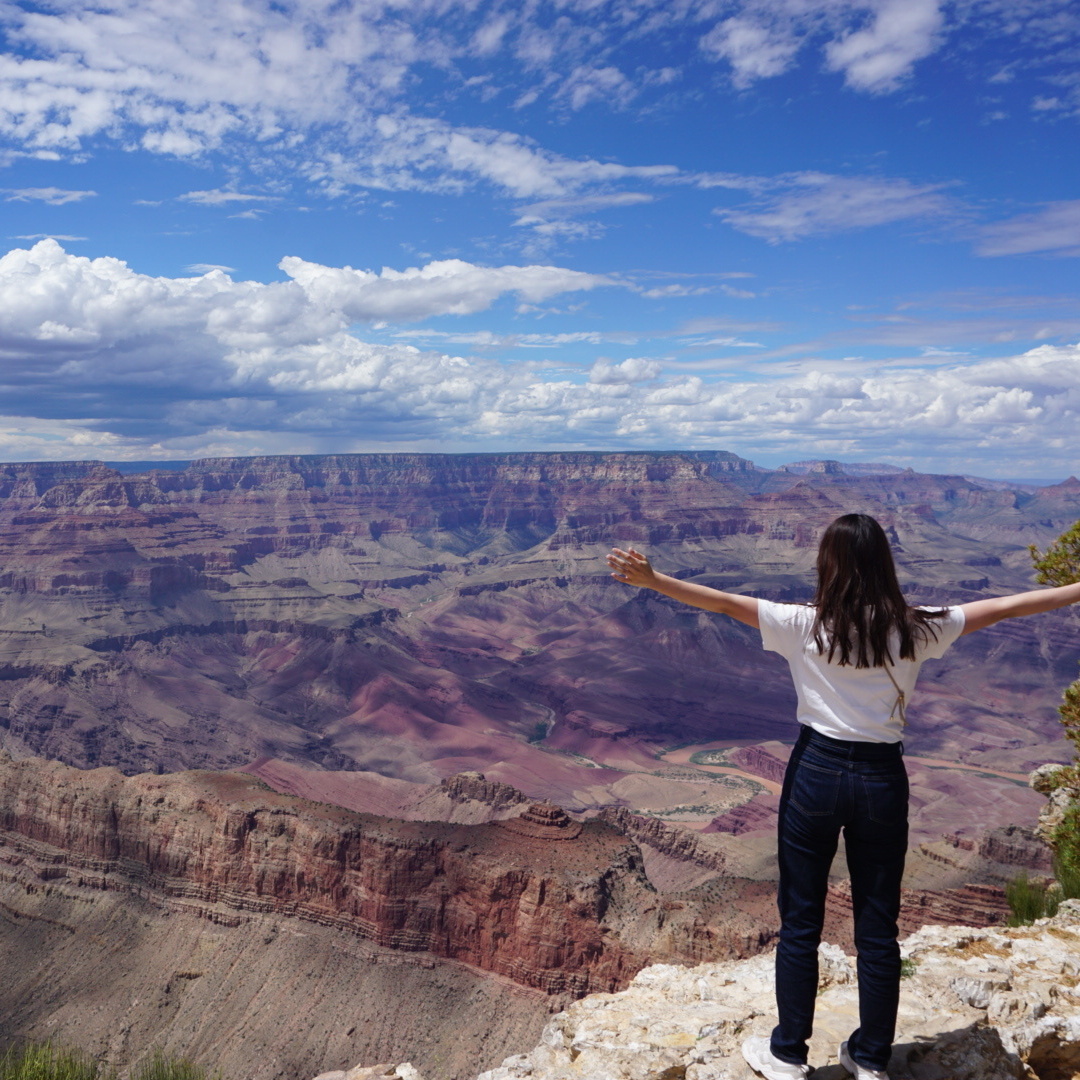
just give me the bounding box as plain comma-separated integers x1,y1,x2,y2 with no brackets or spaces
0,451,1080,808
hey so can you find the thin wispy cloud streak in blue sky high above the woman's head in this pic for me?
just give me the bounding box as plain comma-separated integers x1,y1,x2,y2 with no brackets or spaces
716,173,949,244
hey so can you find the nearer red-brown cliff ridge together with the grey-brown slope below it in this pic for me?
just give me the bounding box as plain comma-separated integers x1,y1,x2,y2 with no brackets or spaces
0,755,1035,1080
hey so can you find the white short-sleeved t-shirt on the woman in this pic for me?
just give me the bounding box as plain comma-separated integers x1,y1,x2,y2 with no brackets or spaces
757,600,963,742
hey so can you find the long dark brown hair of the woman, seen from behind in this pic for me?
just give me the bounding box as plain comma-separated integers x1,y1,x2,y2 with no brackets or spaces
813,514,945,667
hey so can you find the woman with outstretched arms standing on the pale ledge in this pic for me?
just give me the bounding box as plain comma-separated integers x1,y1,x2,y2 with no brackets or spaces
607,514,1080,1080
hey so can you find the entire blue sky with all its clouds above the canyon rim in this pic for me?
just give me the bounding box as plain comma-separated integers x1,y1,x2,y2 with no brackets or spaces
0,0,1080,477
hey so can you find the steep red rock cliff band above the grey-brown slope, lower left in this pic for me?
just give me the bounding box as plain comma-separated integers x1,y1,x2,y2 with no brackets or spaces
0,757,658,994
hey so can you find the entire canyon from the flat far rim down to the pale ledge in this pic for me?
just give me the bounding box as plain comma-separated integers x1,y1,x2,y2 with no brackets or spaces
0,451,1080,1080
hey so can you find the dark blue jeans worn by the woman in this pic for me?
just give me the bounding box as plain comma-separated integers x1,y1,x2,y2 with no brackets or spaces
772,726,907,1069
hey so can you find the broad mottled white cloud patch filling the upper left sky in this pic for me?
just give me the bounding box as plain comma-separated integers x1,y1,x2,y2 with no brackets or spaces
0,0,675,204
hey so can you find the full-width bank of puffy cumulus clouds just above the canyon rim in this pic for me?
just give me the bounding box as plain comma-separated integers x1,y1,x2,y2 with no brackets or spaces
0,241,1080,471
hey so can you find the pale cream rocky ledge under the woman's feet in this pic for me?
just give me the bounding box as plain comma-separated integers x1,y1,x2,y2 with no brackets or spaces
334,901,1080,1080
